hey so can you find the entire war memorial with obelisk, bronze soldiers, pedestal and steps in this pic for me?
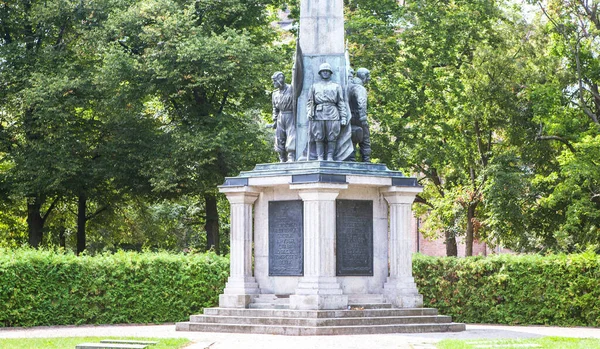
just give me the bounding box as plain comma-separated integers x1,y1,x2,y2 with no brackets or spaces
177,0,465,335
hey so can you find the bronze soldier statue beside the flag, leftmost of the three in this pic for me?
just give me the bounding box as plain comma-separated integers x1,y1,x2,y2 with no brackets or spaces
271,72,296,162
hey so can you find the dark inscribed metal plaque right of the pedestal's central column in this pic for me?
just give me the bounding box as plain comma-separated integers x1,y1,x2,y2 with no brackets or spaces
335,200,373,276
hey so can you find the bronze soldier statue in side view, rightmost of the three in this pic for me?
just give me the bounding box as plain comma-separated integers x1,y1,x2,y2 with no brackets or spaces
348,68,371,162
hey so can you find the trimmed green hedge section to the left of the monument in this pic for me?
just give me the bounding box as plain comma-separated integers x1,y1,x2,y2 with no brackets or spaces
0,249,229,327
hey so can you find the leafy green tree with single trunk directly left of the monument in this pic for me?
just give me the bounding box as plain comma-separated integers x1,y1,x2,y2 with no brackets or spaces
100,0,276,251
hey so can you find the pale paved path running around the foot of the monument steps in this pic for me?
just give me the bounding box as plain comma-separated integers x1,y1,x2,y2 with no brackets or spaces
0,324,600,349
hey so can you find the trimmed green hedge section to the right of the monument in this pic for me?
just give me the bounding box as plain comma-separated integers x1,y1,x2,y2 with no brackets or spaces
413,253,600,327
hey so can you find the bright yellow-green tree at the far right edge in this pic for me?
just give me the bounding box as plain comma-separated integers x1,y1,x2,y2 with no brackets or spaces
510,0,600,251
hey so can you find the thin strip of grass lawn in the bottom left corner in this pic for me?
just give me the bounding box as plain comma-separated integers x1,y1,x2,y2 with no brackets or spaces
0,337,190,349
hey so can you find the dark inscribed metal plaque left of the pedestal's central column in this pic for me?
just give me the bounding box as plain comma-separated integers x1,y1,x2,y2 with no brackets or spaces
269,200,304,276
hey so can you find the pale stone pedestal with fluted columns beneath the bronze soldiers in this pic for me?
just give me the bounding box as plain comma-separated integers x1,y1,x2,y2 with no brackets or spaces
219,161,423,310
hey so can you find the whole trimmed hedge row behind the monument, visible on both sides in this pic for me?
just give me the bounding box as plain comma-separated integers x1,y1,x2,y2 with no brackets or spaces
0,249,600,327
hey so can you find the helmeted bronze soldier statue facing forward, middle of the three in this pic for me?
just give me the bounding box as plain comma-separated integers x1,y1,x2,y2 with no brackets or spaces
306,63,348,161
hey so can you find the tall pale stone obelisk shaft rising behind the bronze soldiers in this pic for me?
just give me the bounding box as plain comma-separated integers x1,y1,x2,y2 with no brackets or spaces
296,0,354,161
